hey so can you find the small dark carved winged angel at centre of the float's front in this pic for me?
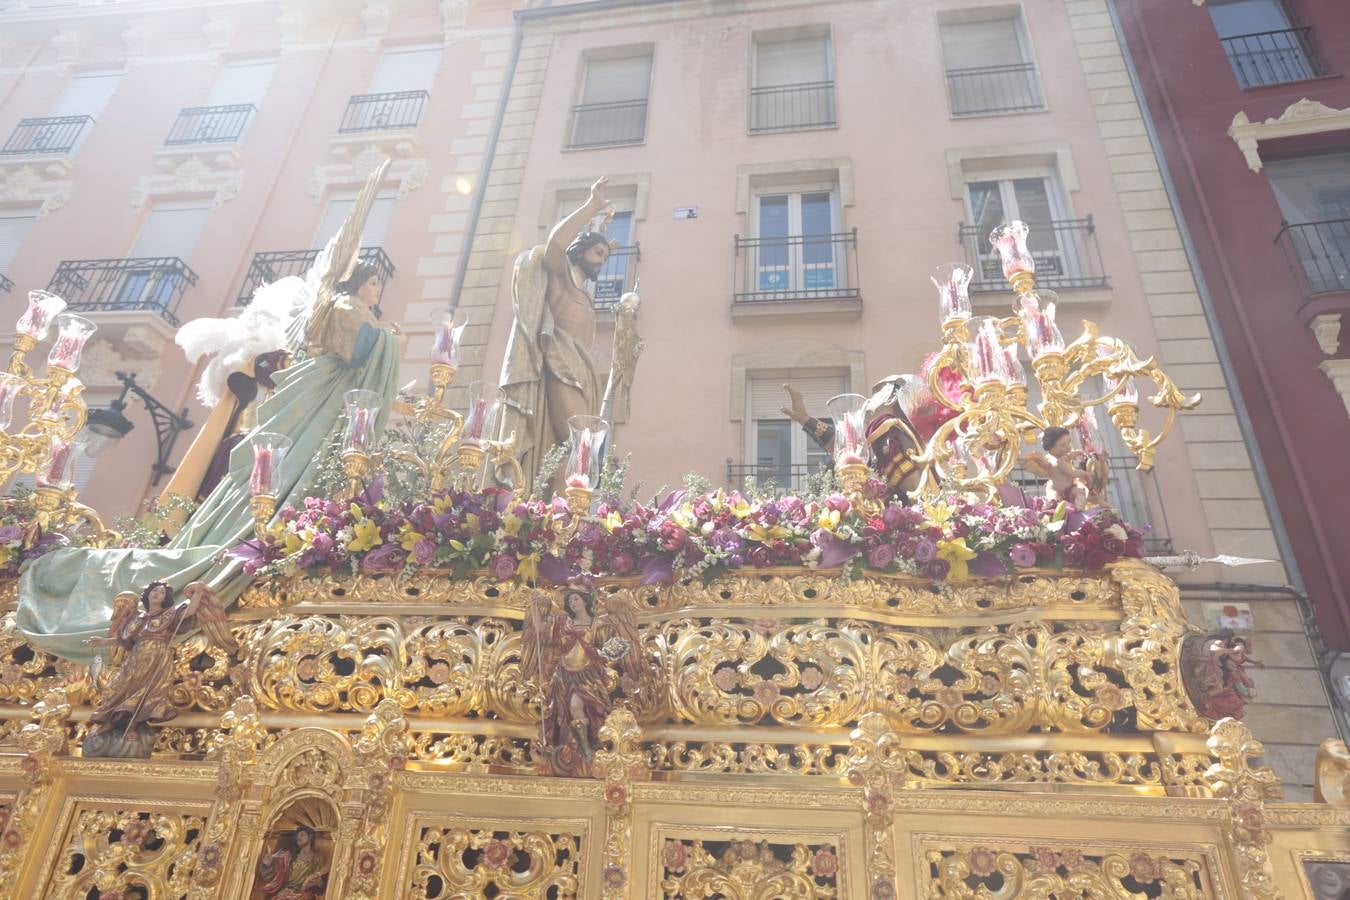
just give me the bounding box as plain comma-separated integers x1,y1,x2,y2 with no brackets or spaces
521,588,656,779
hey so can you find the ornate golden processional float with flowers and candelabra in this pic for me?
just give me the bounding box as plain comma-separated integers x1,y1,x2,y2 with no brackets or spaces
0,214,1350,900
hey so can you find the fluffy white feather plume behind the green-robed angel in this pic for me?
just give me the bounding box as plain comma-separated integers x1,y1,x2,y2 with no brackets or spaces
174,275,306,406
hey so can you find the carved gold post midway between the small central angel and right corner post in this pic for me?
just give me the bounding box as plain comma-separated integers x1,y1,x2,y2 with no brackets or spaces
846,712,902,900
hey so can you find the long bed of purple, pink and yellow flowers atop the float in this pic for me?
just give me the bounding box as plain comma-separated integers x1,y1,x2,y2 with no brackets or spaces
232,486,1143,584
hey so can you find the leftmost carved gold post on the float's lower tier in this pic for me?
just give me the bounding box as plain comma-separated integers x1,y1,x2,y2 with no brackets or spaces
0,687,70,896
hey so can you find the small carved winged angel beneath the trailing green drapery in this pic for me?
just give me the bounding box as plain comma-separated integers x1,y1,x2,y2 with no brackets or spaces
81,582,235,758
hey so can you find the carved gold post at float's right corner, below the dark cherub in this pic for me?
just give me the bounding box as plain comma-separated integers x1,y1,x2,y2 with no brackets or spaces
1204,718,1284,900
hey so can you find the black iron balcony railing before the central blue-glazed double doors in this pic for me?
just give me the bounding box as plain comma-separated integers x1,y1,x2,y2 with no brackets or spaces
733,228,861,304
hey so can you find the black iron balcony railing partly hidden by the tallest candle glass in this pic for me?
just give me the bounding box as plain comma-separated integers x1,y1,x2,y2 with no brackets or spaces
957,216,1110,290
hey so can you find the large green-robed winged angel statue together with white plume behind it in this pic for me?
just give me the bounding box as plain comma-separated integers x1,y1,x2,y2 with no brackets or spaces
18,161,401,663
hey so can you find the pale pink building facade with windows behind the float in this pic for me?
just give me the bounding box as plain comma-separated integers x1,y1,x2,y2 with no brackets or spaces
0,0,1335,789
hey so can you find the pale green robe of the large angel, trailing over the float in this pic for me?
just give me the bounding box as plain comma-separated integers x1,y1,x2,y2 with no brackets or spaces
16,325,400,663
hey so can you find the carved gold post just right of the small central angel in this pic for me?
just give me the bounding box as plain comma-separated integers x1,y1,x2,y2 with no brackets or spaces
591,708,652,900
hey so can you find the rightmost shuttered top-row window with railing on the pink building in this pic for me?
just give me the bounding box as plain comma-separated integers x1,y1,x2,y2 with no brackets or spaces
941,18,1045,116
